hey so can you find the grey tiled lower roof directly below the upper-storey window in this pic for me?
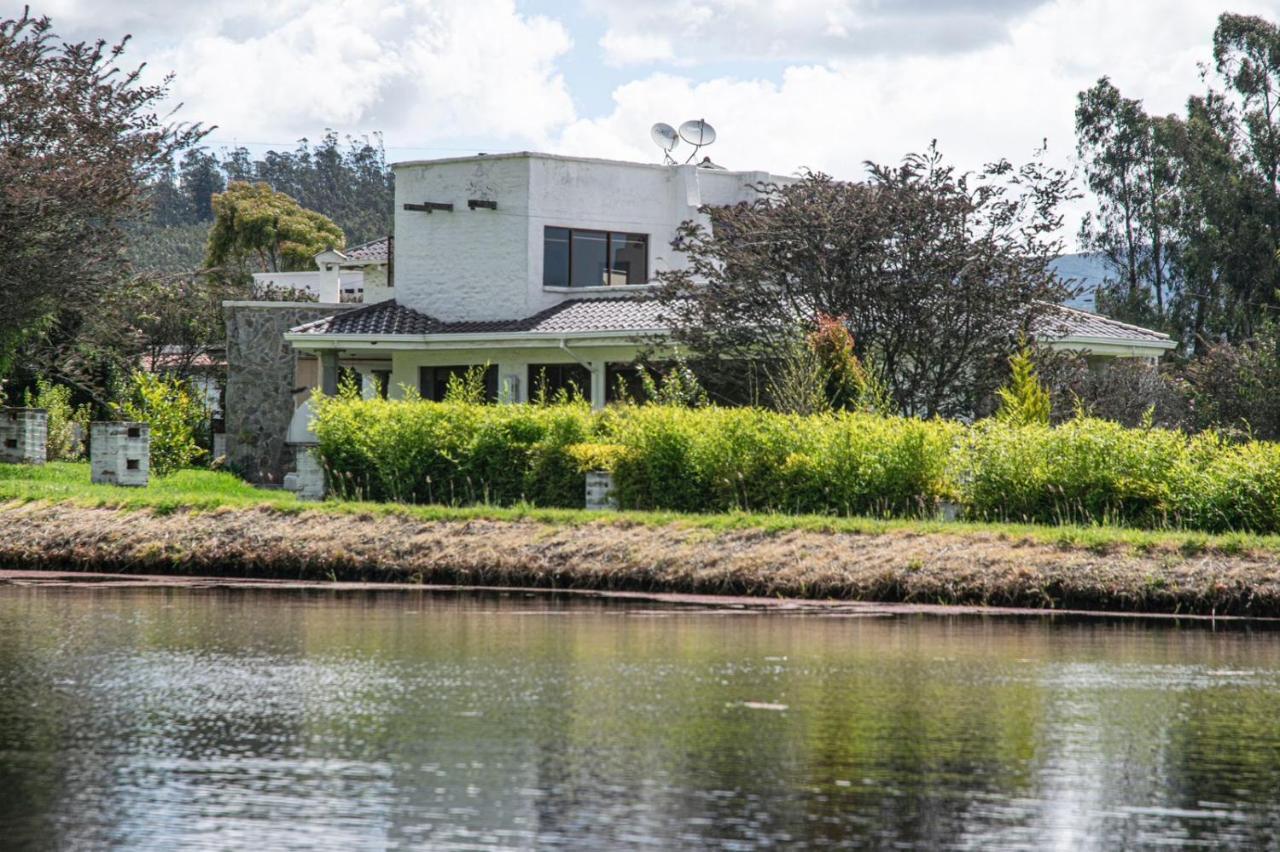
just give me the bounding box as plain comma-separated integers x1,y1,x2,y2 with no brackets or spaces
292,297,667,336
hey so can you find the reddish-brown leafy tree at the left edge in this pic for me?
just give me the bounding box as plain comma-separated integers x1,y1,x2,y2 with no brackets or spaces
0,12,206,375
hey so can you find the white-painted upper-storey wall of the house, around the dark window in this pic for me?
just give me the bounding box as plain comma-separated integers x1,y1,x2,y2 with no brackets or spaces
394,154,788,320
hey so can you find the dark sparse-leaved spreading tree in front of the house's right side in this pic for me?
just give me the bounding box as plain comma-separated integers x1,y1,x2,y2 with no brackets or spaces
659,146,1074,416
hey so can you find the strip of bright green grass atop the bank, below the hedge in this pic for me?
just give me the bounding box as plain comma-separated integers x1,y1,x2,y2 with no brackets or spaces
0,462,1280,555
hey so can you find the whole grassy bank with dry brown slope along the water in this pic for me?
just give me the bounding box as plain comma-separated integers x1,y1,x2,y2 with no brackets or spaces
0,466,1280,617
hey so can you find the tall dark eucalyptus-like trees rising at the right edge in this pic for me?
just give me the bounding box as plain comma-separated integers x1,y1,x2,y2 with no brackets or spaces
1076,14,1280,345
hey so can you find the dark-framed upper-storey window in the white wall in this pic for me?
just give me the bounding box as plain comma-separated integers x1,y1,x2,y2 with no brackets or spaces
543,228,649,287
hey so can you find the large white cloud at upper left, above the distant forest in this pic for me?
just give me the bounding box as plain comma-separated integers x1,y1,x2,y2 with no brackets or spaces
41,0,575,145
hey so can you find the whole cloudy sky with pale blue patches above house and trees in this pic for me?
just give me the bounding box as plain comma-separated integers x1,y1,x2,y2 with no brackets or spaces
22,0,1280,244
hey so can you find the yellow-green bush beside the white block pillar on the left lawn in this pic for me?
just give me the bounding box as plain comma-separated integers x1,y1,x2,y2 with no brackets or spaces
120,372,209,476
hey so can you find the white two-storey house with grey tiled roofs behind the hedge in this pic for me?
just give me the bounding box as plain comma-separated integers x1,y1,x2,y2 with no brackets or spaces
277,152,1174,406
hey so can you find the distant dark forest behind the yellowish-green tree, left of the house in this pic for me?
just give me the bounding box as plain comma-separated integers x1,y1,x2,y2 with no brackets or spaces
129,130,394,274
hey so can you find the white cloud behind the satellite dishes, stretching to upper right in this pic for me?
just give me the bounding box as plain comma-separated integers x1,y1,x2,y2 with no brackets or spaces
558,0,1277,241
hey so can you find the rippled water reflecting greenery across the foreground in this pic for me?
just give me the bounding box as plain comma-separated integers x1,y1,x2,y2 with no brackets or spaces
0,587,1280,849
